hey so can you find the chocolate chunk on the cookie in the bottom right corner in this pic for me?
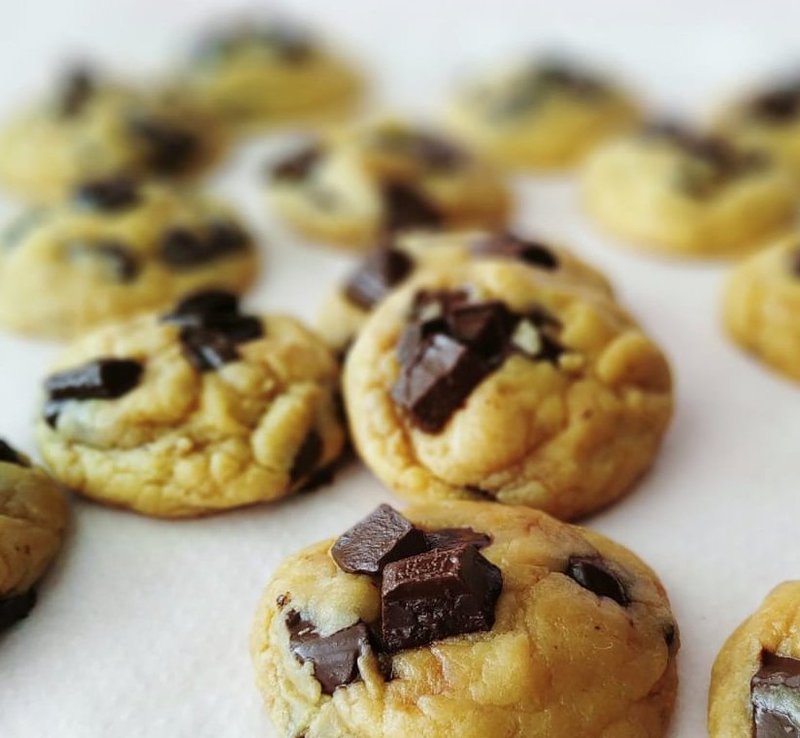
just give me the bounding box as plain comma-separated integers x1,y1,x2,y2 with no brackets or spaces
750,651,800,738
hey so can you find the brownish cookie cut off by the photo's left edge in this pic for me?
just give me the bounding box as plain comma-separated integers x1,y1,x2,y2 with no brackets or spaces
0,439,69,633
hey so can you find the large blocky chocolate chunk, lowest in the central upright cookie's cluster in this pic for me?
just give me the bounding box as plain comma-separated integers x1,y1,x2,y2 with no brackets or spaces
392,334,491,433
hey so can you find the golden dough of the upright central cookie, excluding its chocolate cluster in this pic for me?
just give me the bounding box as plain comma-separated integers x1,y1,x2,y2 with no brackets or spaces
344,261,672,519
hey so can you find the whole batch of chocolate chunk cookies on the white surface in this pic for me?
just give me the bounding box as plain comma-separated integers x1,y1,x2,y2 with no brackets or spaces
0,12,800,738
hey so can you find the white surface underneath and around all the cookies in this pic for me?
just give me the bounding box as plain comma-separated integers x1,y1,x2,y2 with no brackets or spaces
0,0,800,738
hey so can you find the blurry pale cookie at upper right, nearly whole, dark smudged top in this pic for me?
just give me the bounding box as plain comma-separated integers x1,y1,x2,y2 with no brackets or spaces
582,125,795,257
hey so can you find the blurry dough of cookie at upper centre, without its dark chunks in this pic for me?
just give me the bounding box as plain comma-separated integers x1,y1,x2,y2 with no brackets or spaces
268,120,511,250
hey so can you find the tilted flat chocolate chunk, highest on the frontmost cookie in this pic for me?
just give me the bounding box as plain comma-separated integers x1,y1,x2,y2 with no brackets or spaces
331,505,428,576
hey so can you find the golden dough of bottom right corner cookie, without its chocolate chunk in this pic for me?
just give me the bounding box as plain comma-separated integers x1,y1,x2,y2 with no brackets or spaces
708,582,800,738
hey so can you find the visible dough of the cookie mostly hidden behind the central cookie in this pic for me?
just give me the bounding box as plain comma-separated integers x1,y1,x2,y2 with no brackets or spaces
317,231,612,354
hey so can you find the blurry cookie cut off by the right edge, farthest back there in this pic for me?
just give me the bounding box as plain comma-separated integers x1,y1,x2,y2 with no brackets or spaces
715,77,800,175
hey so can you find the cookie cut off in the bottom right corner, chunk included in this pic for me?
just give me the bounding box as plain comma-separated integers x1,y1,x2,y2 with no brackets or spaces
708,582,800,738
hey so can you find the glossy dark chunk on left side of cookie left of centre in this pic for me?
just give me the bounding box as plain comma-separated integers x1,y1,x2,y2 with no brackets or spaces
44,359,144,400
